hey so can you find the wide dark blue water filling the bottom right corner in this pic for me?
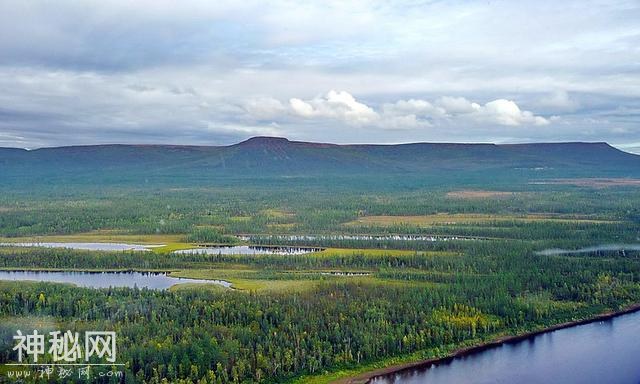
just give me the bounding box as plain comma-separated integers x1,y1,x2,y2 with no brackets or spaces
370,312,640,384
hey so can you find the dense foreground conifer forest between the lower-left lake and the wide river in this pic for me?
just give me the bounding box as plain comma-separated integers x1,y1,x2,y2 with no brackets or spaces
0,279,640,383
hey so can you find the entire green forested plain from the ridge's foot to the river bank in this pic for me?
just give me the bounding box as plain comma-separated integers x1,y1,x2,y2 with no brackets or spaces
0,178,640,383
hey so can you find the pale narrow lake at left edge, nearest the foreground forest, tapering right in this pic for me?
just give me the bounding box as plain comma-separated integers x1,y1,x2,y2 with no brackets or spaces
0,271,231,289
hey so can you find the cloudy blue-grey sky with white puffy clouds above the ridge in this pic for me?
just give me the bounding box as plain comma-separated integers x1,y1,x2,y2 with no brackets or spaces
0,0,640,153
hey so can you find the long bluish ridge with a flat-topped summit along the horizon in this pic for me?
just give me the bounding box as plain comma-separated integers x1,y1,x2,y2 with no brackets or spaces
0,137,640,188
